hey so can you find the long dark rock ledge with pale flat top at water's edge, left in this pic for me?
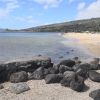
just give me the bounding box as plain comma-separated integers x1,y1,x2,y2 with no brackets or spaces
6,56,52,72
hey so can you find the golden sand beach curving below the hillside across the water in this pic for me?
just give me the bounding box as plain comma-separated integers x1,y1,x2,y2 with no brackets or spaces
63,33,100,57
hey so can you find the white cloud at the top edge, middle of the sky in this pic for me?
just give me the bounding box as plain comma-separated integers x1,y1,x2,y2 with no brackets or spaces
33,0,63,9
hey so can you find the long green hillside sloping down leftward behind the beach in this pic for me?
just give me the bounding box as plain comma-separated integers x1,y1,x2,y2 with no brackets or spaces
20,18,100,32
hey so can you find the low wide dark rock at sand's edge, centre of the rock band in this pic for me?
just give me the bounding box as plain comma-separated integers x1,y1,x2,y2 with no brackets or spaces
45,74,63,84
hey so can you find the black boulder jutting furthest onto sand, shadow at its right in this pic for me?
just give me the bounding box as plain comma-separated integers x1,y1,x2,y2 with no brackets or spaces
70,75,85,92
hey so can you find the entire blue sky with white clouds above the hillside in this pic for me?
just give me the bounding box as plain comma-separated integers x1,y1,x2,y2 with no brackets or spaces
0,0,100,29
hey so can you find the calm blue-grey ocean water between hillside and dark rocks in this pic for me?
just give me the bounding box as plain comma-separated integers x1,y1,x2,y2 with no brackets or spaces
0,33,92,63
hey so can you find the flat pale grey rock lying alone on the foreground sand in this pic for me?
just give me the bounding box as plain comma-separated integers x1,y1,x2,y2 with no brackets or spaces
9,83,30,94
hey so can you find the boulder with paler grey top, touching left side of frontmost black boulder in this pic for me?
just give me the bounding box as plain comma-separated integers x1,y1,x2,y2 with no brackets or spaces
60,71,75,87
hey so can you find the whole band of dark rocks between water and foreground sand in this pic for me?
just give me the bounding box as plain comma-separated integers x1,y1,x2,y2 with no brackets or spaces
0,56,100,100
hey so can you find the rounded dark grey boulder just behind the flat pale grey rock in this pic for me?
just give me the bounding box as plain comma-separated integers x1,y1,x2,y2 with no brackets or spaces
10,71,28,83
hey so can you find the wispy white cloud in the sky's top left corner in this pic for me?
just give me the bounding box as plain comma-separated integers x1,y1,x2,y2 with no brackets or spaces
0,0,19,17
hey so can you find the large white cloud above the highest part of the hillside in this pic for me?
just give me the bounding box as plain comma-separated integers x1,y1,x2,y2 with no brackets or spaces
76,0,100,19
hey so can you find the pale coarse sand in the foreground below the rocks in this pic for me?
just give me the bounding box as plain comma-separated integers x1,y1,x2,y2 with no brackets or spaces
0,79,100,100
